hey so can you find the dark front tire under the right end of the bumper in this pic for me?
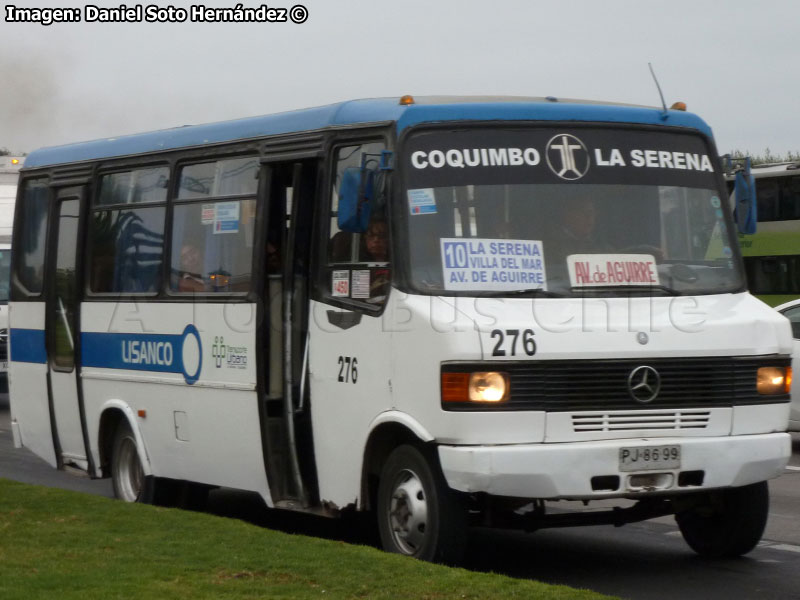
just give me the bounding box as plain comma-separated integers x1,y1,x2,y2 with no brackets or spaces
675,481,769,558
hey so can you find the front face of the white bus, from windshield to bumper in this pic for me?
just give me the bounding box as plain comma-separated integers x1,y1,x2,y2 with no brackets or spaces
376,123,790,498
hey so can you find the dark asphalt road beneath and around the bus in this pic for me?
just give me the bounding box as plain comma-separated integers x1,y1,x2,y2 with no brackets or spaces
0,396,800,600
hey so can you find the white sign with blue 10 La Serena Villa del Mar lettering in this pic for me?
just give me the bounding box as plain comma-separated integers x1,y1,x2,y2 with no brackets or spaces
441,238,547,291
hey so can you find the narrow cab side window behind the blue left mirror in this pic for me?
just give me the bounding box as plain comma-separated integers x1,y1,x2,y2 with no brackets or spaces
326,142,391,305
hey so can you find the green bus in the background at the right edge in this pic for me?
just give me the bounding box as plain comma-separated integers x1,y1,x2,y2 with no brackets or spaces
728,162,800,306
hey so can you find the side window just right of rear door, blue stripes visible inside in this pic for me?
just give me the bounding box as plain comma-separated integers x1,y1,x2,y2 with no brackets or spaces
89,167,169,294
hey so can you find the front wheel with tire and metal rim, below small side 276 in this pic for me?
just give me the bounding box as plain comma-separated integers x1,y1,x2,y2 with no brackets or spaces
377,445,467,564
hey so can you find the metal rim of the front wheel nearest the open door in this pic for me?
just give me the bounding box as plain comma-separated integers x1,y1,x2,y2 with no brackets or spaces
388,469,428,555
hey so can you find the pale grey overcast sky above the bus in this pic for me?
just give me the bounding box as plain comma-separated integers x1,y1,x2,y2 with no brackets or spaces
0,0,800,154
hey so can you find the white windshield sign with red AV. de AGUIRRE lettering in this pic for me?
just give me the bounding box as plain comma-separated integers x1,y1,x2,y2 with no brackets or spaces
567,254,659,287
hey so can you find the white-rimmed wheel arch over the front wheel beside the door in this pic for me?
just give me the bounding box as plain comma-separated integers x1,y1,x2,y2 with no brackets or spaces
359,411,434,510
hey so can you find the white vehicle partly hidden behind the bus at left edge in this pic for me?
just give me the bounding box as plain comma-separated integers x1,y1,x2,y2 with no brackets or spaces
0,156,25,390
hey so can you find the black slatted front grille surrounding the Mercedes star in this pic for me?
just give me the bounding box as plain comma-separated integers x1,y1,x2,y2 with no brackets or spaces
442,356,790,412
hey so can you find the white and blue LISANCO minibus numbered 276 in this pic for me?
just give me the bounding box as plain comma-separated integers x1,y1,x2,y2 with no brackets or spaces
10,96,791,562
